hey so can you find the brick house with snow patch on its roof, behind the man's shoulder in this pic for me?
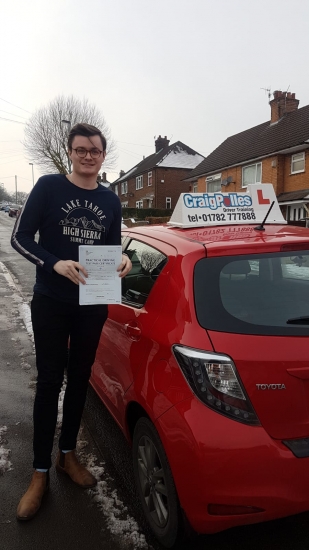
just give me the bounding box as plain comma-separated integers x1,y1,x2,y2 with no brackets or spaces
110,136,204,209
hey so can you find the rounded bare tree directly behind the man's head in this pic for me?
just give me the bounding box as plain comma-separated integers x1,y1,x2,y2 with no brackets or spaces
24,96,117,174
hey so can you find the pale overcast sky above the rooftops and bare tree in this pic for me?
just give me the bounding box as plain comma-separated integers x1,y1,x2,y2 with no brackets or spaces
0,0,309,196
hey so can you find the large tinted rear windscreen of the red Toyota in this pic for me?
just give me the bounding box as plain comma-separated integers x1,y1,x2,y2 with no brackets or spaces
194,250,309,335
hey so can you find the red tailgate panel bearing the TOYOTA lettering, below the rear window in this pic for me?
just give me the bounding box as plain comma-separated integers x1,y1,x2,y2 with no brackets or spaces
209,331,309,439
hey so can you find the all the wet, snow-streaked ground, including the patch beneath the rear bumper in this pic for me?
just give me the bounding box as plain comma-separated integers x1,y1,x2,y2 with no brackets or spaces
0,208,309,550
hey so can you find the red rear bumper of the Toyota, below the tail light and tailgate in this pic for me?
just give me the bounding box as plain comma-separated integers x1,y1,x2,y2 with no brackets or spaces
156,397,309,533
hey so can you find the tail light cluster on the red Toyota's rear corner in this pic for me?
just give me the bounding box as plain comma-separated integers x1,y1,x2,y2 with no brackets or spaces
173,345,260,426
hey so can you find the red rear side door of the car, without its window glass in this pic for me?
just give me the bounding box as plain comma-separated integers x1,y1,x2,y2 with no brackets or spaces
92,235,176,426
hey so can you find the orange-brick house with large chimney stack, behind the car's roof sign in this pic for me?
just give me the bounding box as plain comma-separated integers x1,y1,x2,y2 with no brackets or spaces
185,91,309,223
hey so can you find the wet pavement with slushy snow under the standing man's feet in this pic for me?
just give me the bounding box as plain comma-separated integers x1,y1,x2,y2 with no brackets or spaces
0,220,149,550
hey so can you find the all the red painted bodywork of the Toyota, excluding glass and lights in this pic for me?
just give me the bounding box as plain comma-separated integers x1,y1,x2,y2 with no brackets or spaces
91,225,309,533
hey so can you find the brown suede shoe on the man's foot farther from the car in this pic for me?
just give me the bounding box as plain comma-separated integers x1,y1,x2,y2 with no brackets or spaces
16,470,49,521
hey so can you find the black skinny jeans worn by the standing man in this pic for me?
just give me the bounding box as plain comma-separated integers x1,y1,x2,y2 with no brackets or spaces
31,293,107,468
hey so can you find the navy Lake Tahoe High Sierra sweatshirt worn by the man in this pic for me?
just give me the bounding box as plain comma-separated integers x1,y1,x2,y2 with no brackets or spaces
11,174,121,304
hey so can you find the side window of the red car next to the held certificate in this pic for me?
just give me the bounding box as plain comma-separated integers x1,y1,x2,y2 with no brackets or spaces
122,239,167,307
